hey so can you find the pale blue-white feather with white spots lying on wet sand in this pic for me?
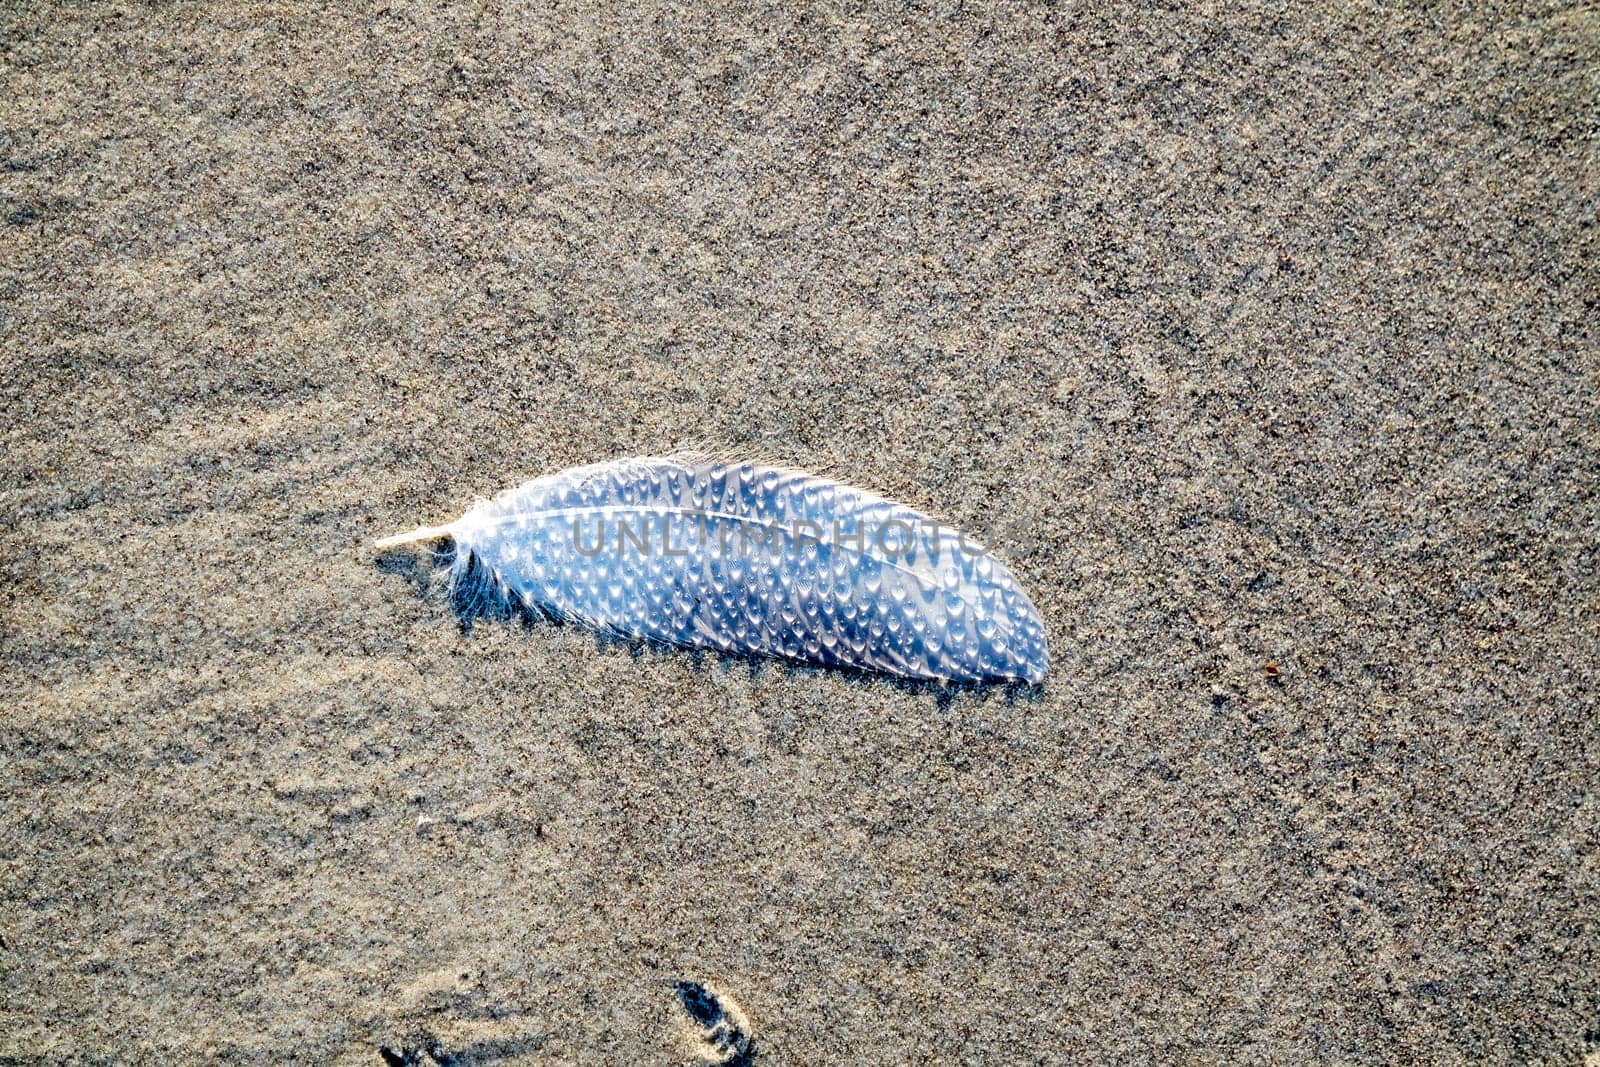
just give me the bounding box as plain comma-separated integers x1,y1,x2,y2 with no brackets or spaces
378,456,1048,683
